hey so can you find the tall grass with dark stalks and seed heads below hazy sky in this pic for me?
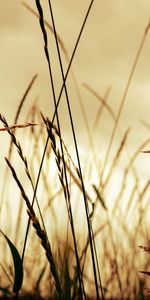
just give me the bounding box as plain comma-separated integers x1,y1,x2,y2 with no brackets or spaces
0,0,150,300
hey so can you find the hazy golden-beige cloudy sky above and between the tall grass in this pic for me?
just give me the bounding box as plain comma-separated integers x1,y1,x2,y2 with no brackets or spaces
0,0,150,199
